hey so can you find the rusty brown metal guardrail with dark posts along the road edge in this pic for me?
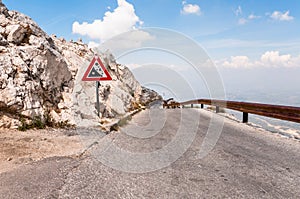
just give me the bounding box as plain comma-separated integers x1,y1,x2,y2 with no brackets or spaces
164,99,300,123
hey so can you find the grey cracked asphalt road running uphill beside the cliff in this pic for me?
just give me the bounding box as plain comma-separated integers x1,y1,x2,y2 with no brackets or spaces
0,109,300,199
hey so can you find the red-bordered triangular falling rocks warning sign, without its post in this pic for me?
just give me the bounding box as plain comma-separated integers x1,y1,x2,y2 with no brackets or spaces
82,57,112,81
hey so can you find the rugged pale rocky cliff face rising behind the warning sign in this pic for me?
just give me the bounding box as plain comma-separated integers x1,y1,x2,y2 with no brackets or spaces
0,1,160,128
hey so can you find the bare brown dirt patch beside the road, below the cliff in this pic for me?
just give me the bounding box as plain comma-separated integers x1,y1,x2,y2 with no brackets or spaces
0,129,84,173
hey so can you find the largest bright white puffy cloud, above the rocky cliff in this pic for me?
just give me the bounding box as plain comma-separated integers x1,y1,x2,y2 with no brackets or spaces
72,0,143,41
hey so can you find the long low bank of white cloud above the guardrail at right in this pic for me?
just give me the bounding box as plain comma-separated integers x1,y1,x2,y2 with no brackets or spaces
215,51,300,68
